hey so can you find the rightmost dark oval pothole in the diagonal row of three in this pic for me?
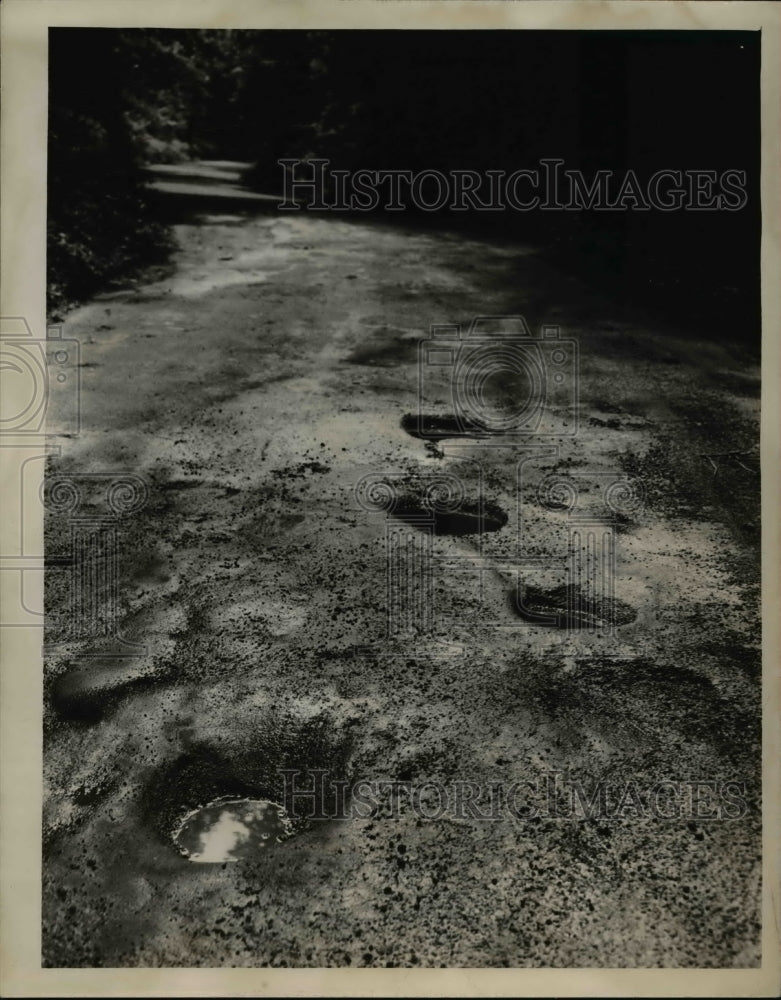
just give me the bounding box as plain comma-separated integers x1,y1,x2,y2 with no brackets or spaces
511,584,637,629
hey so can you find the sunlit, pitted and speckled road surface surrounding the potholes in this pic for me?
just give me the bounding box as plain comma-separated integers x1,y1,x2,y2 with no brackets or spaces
44,160,760,966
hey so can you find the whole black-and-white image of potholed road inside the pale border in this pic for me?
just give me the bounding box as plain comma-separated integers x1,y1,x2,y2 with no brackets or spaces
0,3,778,995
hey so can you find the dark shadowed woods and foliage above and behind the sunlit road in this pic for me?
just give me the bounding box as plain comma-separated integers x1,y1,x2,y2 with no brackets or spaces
48,28,760,351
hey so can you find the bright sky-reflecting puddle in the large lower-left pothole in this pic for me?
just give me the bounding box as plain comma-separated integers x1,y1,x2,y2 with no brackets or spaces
174,799,293,864
